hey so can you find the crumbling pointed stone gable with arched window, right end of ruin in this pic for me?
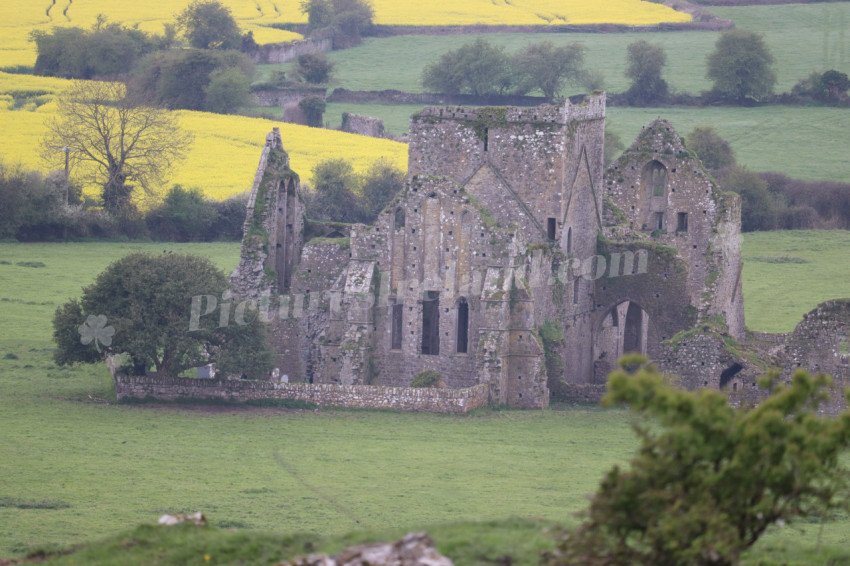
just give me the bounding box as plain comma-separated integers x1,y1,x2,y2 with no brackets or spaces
605,119,744,339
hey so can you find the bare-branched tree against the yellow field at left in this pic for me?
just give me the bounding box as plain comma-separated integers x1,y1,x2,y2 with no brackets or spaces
42,81,192,213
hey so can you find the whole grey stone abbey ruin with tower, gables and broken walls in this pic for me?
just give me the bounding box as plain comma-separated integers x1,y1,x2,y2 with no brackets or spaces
217,93,850,408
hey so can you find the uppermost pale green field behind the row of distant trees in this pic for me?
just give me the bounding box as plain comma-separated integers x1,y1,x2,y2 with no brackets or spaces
266,2,850,94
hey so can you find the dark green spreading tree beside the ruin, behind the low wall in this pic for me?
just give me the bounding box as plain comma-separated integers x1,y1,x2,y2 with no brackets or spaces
53,253,271,377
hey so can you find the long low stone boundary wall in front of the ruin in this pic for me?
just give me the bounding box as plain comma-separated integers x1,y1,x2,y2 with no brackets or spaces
115,375,490,415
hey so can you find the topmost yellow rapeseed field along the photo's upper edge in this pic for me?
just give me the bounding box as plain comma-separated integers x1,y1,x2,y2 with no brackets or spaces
0,0,691,67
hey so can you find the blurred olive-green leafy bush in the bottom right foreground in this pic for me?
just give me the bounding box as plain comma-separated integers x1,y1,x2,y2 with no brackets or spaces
548,356,850,566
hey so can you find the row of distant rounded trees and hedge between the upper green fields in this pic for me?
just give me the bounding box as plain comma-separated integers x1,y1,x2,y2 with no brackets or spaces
421,29,850,106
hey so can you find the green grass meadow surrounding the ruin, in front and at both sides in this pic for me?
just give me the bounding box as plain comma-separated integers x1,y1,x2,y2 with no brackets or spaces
0,232,850,564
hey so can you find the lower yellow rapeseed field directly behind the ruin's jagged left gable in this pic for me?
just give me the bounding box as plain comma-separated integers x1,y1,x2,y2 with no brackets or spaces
0,83,407,205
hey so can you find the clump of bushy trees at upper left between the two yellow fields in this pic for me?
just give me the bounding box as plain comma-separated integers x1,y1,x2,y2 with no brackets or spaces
31,0,256,113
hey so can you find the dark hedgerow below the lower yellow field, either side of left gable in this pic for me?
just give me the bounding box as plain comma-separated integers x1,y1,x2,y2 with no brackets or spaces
0,154,405,242
